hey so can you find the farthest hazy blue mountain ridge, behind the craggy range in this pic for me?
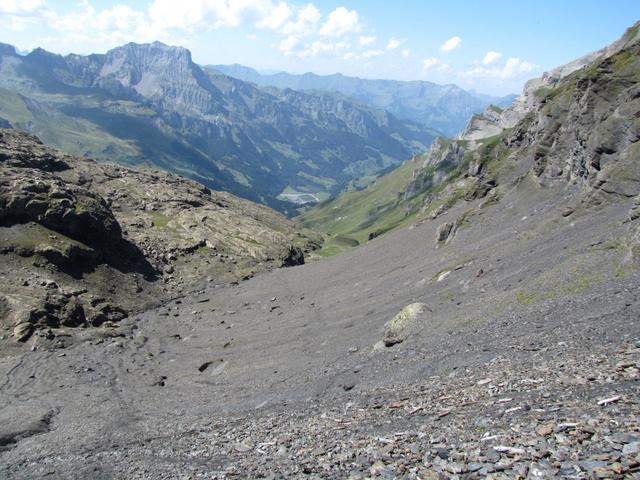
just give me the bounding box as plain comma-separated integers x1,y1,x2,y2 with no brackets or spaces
208,64,516,136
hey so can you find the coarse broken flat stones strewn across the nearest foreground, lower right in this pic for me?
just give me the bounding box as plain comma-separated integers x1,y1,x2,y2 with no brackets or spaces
18,334,640,480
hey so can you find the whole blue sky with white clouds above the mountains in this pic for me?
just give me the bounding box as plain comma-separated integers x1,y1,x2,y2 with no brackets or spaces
0,0,640,95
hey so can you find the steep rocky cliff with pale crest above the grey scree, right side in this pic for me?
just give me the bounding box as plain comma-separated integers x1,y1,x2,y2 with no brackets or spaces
406,21,640,204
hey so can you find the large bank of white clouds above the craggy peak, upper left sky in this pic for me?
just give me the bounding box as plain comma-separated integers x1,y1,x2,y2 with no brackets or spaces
0,0,420,69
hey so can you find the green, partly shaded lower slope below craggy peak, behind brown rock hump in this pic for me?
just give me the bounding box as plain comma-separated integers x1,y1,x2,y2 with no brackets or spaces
0,88,244,201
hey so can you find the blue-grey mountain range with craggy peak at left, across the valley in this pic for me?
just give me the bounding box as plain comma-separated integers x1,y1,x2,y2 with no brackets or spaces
0,42,437,211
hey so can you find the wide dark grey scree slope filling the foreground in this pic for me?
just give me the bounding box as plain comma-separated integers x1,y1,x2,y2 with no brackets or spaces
0,181,640,479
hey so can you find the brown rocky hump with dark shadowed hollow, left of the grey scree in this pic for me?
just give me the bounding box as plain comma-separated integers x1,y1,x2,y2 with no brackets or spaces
0,130,320,343
